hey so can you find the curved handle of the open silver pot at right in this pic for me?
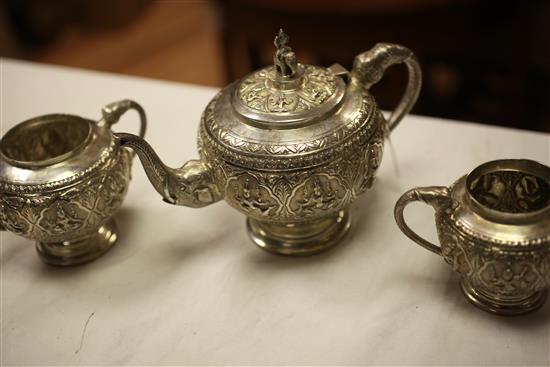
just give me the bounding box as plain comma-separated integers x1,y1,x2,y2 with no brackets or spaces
394,186,452,255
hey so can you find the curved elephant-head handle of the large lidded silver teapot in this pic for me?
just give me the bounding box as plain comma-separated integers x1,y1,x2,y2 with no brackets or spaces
351,43,422,131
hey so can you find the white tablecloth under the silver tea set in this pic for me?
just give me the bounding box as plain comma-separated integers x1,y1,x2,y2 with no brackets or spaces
0,59,550,365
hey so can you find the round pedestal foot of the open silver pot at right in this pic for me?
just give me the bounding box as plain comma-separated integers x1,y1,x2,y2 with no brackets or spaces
460,278,548,316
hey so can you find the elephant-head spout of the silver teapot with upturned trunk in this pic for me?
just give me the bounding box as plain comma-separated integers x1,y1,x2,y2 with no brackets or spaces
114,133,223,208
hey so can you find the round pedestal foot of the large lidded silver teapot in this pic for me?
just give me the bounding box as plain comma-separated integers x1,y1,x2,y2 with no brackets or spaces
246,209,351,256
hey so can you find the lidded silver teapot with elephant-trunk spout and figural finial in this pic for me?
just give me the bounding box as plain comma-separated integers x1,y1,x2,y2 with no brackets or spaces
116,31,421,255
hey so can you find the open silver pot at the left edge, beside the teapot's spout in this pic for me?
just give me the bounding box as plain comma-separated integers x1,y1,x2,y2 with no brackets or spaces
0,100,146,265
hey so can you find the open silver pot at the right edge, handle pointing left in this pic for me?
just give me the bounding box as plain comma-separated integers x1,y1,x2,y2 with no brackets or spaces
395,159,550,315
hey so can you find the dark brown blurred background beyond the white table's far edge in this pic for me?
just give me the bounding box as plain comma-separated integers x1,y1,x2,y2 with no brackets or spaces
0,0,550,132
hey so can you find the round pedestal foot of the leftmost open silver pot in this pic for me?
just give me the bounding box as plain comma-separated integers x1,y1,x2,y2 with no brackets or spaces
36,219,118,266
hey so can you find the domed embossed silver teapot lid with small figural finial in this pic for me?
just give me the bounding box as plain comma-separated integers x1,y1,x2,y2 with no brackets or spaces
232,29,345,129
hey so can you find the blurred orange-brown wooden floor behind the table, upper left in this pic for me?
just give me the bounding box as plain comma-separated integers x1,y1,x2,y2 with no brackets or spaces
32,0,225,86
